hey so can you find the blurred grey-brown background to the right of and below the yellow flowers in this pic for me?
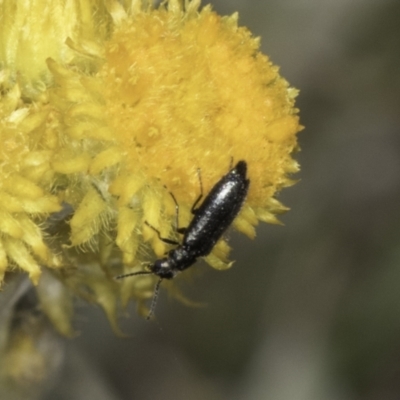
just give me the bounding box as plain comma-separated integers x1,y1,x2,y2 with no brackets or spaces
3,0,400,400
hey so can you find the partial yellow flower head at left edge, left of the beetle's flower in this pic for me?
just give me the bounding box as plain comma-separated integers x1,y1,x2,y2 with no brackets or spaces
0,81,61,283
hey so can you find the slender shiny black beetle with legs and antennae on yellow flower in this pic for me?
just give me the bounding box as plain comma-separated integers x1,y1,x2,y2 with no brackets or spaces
116,161,250,319
